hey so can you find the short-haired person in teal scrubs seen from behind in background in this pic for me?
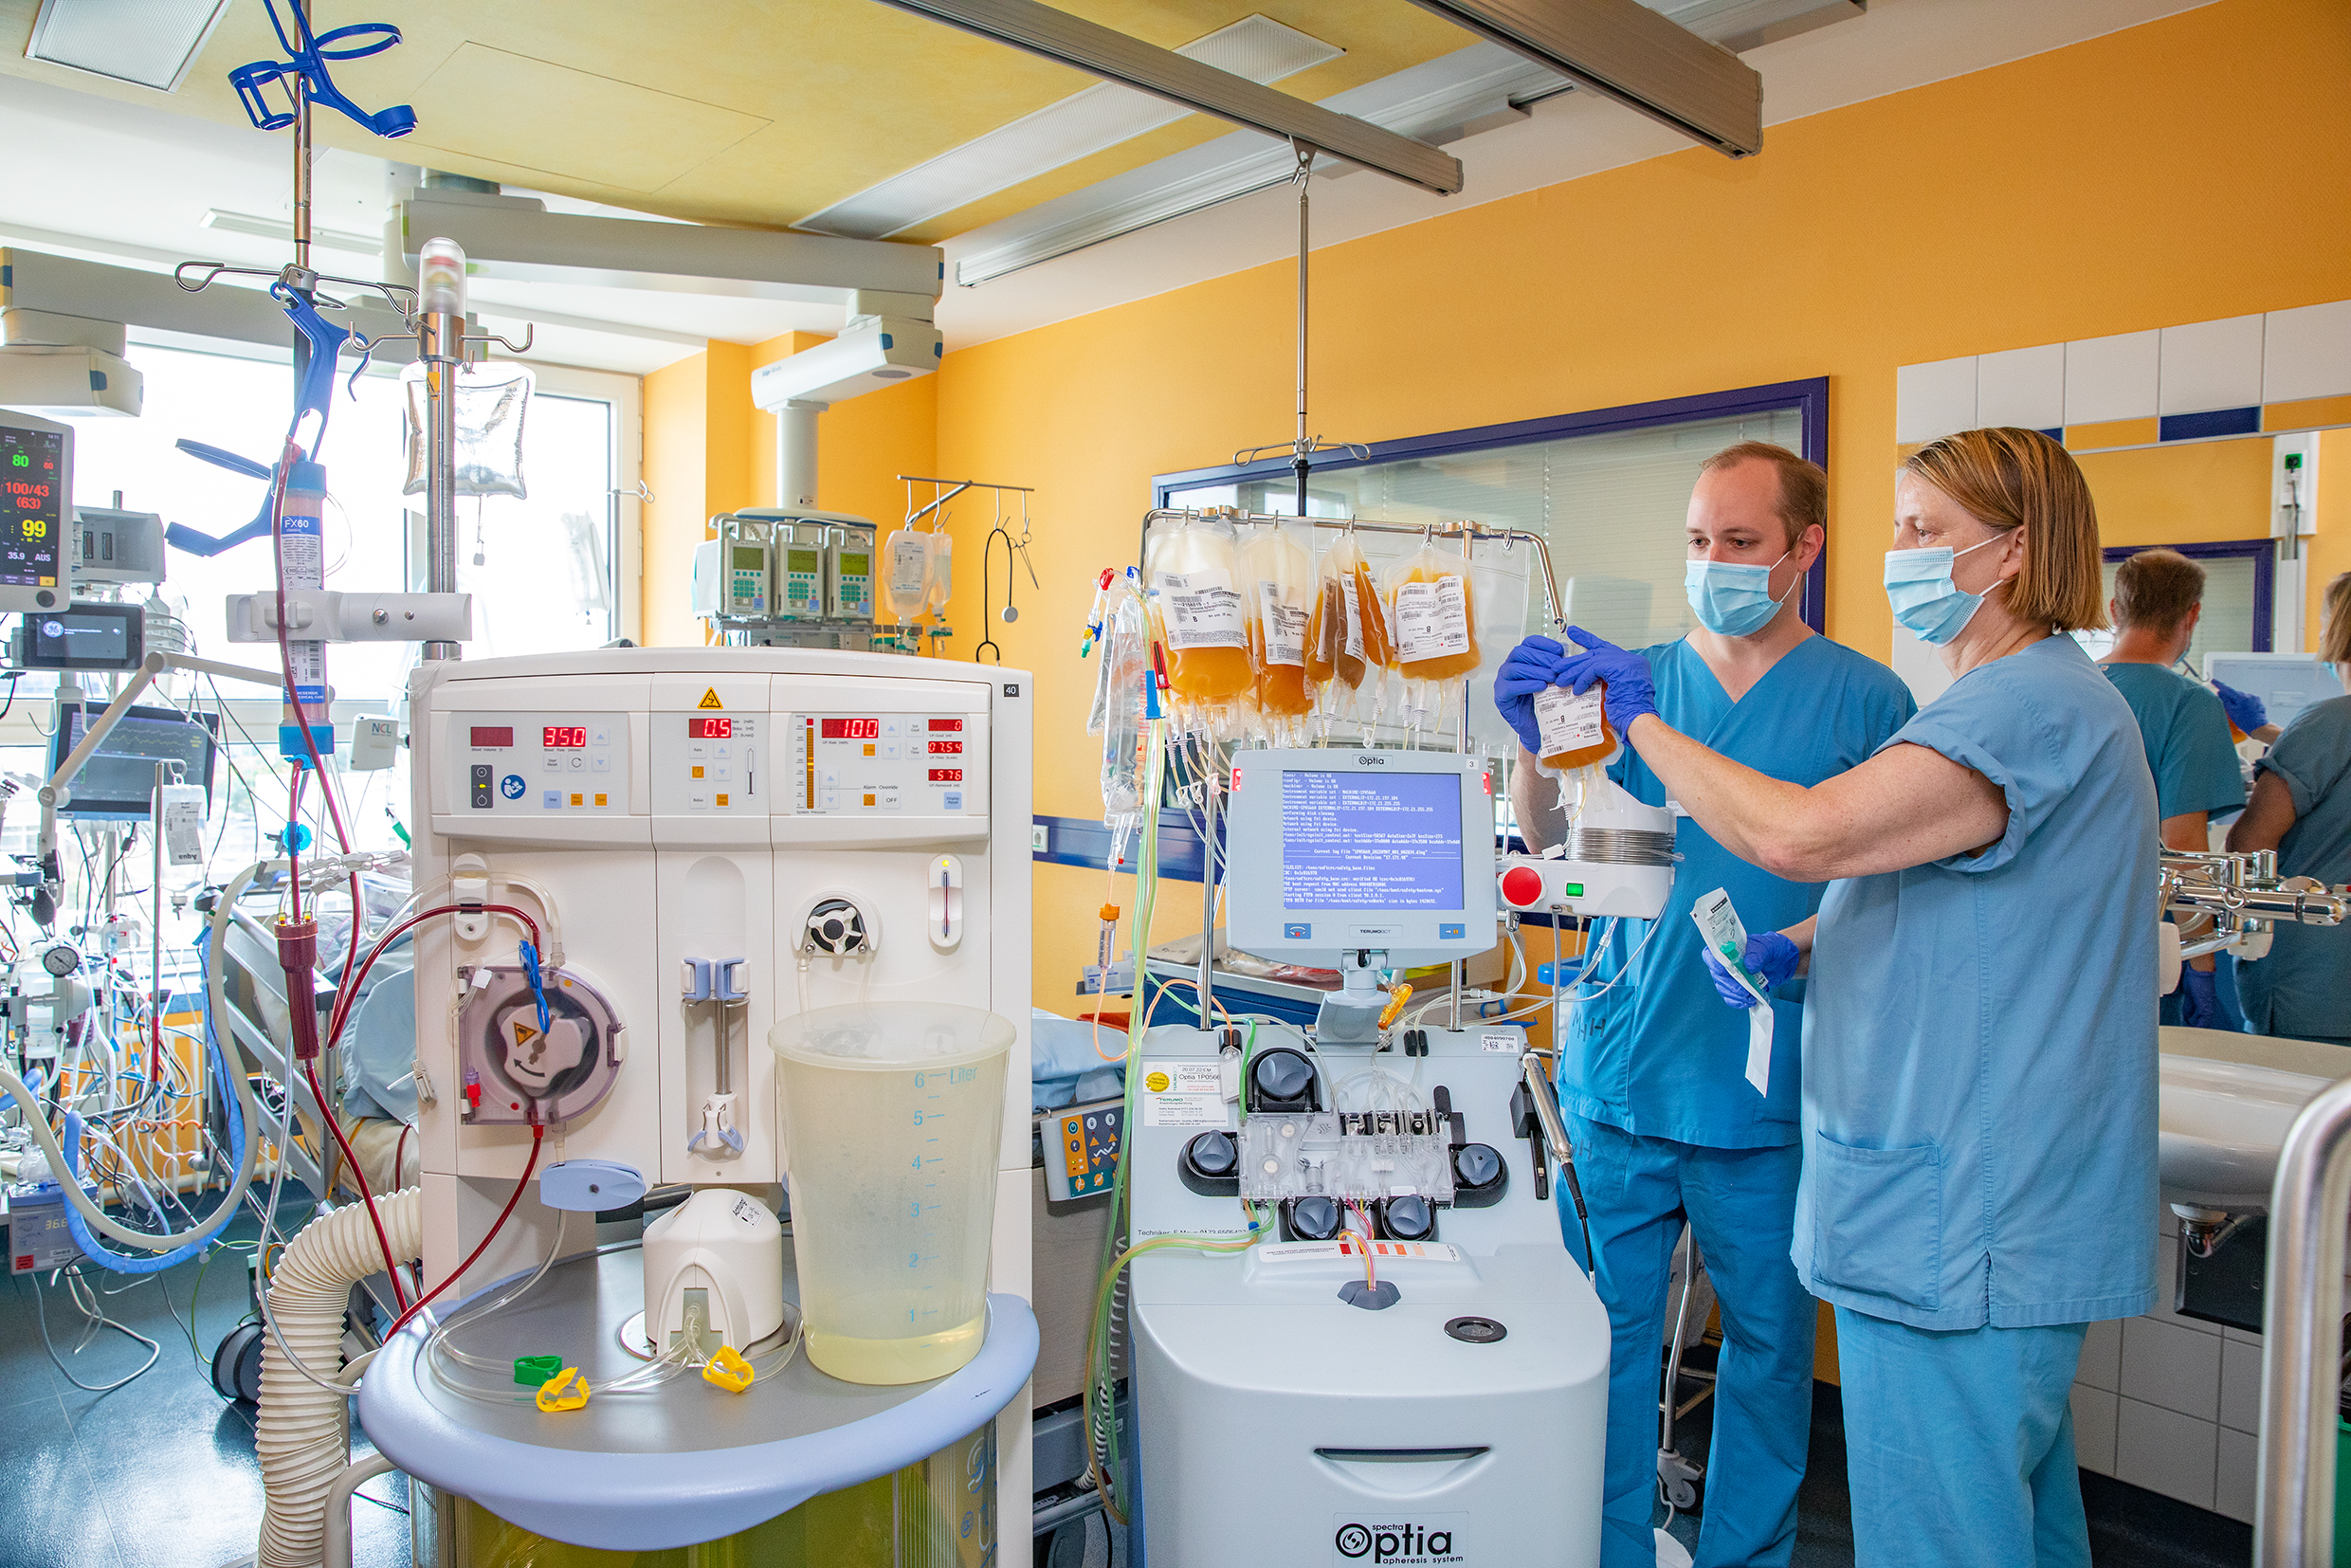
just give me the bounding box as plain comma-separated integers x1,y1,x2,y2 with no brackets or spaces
2100,550,2254,1030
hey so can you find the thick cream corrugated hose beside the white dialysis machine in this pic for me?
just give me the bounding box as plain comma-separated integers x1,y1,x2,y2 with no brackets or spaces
254,1187,426,1568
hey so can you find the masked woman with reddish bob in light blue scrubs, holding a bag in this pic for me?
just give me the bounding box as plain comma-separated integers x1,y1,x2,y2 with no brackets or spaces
1561,428,2159,1568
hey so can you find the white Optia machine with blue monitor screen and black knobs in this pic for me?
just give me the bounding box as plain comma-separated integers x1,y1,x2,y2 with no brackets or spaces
1128,748,1671,1568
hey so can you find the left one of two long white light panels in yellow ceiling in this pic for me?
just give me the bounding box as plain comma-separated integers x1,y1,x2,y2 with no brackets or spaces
794,16,1345,240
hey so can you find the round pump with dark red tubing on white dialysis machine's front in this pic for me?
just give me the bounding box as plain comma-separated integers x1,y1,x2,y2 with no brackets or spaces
456,964,626,1126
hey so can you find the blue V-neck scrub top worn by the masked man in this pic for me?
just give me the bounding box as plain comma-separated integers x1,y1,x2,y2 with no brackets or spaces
1558,637,1919,1150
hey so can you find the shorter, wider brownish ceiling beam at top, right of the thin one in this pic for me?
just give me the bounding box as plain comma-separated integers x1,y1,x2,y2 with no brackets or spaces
1392,0,1763,157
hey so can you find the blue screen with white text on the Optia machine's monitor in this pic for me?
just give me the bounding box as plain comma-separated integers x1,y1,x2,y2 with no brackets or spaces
1282,771,1463,910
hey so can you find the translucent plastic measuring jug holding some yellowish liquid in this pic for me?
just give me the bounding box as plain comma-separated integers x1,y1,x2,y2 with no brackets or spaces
766,1001,1013,1382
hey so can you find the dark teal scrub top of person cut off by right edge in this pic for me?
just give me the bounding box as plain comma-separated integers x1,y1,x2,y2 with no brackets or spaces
2235,696,2351,1039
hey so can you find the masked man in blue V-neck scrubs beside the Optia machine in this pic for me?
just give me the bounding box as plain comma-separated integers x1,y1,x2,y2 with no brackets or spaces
1495,442,1916,1568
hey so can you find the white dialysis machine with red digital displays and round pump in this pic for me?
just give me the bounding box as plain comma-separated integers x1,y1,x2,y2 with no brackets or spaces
411,648,1032,1498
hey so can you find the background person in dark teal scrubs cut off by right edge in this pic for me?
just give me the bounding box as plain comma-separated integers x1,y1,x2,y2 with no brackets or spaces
2229,572,2351,1046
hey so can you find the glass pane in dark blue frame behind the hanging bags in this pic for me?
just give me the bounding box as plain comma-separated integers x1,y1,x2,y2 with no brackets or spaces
1166,407,1803,648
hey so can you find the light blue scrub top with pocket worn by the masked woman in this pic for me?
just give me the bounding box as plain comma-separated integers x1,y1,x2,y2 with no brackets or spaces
1789,637,2160,1328
